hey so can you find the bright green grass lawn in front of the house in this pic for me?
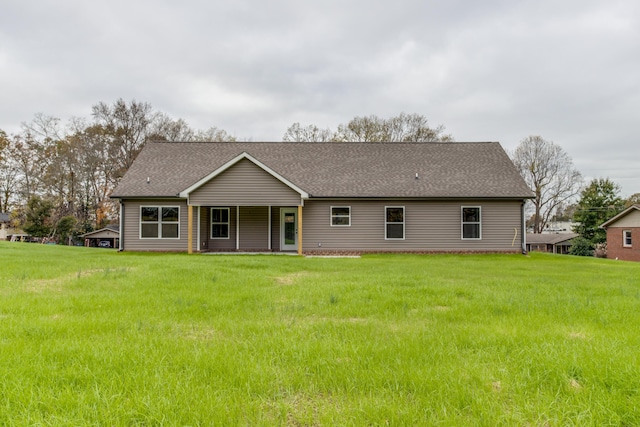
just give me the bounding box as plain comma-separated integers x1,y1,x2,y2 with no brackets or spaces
0,242,640,426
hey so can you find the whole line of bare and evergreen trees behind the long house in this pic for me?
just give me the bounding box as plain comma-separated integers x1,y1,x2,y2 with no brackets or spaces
0,99,640,251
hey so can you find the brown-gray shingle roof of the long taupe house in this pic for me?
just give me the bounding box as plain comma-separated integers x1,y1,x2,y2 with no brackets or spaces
111,142,533,198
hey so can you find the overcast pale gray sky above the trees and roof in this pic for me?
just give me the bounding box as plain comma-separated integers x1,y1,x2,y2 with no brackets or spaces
0,0,640,196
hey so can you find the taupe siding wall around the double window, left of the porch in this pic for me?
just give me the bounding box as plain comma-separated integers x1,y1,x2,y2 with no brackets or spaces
121,199,197,252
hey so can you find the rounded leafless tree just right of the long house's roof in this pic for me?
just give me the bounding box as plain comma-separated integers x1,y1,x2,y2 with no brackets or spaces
512,136,583,233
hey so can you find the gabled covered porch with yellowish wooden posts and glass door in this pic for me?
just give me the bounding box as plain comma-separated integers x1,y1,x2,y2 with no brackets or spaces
180,152,309,255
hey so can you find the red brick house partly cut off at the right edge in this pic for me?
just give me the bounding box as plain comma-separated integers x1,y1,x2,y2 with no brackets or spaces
600,204,640,261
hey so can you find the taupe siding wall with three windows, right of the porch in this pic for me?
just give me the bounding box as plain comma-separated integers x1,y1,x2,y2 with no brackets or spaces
302,200,522,253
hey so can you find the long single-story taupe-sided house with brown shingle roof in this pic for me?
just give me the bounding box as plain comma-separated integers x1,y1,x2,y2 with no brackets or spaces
111,142,533,254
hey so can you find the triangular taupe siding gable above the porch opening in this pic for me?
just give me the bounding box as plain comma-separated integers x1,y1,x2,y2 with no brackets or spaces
189,159,300,206
